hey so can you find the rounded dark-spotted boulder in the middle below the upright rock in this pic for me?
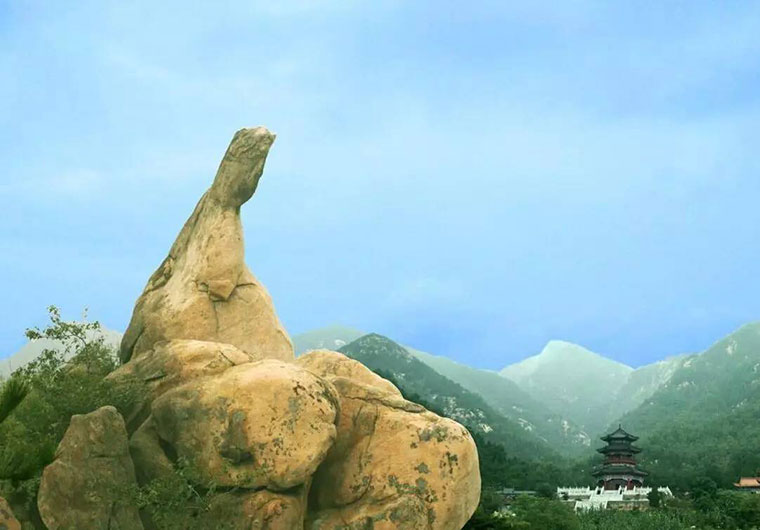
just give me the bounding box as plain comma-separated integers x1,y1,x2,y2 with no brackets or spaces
152,359,338,491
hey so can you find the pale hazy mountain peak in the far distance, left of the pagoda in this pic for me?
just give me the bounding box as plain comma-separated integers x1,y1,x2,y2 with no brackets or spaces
500,340,633,434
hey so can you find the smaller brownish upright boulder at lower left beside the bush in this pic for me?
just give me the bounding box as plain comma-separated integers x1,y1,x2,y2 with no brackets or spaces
37,407,143,530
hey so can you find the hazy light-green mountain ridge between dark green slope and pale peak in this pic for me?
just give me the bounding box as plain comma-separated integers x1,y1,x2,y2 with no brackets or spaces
406,348,591,455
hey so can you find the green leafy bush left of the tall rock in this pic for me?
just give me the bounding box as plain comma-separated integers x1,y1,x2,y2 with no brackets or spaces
0,306,143,512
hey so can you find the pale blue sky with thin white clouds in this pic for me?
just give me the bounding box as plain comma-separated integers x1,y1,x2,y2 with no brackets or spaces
0,0,760,369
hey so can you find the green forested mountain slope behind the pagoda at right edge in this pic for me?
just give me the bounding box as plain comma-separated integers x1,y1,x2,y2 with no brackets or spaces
620,323,760,487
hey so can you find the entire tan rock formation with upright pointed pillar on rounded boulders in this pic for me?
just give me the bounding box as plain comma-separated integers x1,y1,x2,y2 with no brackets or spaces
46,128,480,530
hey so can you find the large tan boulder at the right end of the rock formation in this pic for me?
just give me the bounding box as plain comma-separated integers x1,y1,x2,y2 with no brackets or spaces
297,353,480,530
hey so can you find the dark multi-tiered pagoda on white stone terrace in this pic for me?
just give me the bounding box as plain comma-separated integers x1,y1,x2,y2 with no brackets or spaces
591,425,647,490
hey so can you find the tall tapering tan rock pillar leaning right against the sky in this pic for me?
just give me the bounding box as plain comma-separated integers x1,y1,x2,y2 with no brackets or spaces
120,127,293,362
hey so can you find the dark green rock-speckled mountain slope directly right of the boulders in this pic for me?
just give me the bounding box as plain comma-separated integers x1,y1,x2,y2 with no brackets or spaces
338,333,556,459
